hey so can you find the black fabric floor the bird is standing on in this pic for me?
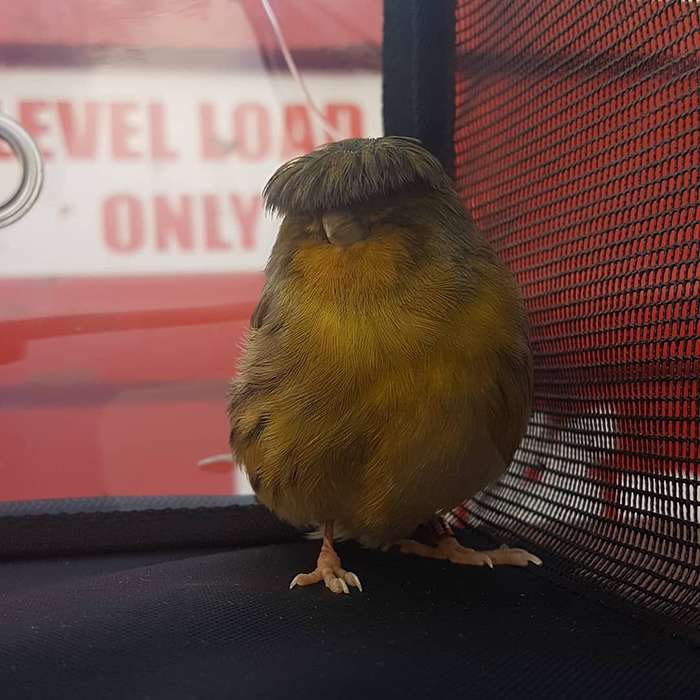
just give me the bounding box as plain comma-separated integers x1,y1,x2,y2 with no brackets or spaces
0,534,700,700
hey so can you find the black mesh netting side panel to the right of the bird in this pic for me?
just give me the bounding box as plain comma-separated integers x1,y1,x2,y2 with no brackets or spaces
454,0,700,626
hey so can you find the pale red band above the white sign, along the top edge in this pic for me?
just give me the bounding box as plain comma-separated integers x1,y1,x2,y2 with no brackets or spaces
0,0,382,51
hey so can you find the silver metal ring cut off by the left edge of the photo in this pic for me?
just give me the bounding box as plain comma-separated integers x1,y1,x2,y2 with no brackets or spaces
0,114,44,228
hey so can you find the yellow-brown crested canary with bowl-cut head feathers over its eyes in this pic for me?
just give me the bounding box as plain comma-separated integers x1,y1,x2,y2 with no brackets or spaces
229,137,541,593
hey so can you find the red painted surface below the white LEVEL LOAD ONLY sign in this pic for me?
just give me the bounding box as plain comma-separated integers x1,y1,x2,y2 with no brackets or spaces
0,274,263,500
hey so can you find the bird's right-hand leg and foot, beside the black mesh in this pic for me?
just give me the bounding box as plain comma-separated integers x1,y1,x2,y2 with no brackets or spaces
398,516,542,568
